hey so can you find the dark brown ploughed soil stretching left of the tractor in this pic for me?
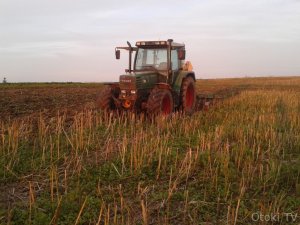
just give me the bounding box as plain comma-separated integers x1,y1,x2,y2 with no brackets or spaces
0,84,103,120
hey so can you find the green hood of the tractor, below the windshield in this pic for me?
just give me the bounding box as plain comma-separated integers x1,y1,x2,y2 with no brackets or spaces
120,71,166,90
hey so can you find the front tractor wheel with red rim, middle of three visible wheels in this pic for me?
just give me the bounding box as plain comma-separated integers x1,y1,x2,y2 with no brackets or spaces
147,88,173,116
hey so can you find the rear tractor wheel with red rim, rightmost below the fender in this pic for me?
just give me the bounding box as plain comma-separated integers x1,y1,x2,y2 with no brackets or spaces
180,77,196,113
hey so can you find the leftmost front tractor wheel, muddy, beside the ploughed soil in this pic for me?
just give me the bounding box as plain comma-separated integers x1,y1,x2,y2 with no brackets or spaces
96,85,120,112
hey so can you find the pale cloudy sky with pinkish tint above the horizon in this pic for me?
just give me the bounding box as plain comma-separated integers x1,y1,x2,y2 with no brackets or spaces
0,0,300,82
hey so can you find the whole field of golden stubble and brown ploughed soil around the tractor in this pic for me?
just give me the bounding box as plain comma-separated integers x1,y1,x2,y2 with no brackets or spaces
0,77,300,225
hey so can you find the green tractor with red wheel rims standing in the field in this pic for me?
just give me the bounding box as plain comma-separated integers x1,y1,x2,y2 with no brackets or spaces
96,39,196,115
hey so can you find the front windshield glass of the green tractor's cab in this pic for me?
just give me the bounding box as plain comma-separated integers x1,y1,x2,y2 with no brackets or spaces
135,48,168,70
